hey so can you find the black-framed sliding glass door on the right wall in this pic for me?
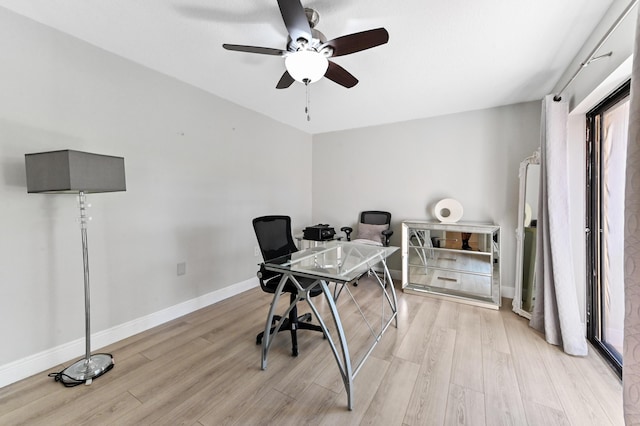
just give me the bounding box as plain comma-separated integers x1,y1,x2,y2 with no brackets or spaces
587,82,629,375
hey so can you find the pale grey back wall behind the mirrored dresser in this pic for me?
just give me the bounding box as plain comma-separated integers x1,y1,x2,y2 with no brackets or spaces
313,102,541,296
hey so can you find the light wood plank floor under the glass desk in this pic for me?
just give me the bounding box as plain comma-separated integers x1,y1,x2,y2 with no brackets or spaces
0,283,624,426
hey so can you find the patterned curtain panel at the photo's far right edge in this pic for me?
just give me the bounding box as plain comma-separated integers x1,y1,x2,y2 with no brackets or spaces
622,6,640,425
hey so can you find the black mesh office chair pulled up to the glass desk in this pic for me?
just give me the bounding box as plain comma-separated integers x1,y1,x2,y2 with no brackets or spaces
253,216,322,356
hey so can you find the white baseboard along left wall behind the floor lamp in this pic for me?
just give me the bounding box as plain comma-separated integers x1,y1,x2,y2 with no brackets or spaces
0,278,259,388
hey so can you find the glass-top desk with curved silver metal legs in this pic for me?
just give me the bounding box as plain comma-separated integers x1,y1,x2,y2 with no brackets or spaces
261,241,398,410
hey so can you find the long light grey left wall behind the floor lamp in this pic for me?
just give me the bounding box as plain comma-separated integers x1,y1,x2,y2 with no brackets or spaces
0,8,311,380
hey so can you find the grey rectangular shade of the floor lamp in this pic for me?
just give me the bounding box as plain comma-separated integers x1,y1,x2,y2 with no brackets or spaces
25,149,126,194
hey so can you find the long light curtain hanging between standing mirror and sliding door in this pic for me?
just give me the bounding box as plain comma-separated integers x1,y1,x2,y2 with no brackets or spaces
530,95,587,356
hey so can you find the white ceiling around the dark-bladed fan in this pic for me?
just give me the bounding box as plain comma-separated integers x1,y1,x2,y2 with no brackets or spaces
0,0,613,134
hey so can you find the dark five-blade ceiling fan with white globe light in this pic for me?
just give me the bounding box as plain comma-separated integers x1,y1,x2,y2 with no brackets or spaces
222,0,389,89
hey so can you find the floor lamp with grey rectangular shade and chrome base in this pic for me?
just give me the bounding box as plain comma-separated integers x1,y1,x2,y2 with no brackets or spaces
25,149,126,385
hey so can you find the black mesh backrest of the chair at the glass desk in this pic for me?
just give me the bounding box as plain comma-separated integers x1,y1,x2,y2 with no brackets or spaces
253,216,298,261
